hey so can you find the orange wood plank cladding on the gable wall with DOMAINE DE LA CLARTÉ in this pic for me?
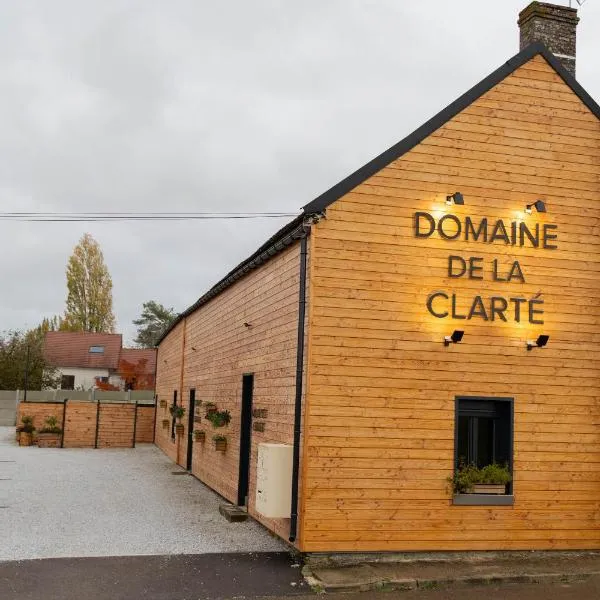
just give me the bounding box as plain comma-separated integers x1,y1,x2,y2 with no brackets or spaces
300,56,600,552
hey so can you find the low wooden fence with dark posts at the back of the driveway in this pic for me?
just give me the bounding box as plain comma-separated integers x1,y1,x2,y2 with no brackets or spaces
17,399,156,448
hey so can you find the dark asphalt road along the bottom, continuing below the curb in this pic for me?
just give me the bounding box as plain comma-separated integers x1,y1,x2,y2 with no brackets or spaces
0,553,600,600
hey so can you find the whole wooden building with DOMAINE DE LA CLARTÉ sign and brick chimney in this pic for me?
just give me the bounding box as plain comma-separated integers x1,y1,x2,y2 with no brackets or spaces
156,2,600,552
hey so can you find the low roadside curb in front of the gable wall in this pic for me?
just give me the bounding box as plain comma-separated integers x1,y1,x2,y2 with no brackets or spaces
302,565,600,593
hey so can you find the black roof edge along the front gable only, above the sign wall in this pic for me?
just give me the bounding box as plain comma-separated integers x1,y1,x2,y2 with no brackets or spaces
304,42,600,214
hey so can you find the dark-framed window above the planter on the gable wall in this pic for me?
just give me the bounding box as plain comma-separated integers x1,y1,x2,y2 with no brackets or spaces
455,398,513,494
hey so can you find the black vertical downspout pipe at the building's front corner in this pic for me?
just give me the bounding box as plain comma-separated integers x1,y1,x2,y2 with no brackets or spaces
289,229,308,542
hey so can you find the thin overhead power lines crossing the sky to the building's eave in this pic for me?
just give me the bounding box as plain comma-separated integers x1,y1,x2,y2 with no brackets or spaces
0,212,298,223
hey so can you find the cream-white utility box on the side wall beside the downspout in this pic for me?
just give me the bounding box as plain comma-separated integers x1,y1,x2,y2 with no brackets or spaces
256,444,294,519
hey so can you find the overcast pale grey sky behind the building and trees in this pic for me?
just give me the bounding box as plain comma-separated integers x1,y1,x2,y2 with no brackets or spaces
0,0,600,340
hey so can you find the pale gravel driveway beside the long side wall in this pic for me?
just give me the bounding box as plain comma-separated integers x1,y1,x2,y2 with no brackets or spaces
0,427,287,560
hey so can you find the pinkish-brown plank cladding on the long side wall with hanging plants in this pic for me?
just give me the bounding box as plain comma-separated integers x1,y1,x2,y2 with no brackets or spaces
156,242,310,539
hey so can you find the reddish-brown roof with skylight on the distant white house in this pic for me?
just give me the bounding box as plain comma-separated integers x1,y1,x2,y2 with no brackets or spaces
44,331,123,369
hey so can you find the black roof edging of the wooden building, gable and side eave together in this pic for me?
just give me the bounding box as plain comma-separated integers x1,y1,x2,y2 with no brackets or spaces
157,42,600,345
